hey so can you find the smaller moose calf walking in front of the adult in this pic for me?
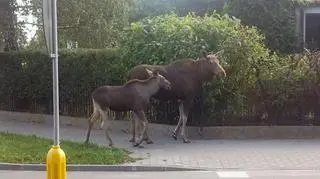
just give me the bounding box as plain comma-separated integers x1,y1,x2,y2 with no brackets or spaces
85,69,171,147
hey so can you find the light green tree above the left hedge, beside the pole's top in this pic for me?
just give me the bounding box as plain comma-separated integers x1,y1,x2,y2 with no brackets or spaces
25,0,132,48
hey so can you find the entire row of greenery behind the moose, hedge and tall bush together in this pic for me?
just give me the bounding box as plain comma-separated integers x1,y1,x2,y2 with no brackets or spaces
0,13,320,125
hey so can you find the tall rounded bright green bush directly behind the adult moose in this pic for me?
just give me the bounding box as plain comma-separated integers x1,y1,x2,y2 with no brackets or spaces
120,13,277,124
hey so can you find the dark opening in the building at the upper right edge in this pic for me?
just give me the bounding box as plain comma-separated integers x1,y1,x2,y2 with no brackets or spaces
305,13,320,50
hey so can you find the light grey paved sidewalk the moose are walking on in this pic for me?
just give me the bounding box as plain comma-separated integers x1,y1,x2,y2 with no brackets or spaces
0,119,320,170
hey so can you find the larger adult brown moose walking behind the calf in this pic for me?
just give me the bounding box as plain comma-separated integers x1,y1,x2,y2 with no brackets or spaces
129,51,226,143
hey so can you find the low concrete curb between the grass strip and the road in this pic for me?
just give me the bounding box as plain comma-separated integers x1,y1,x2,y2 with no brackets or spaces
0,163,204,172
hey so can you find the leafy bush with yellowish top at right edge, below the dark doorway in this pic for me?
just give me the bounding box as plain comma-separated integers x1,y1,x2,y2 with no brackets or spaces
251,50,320,125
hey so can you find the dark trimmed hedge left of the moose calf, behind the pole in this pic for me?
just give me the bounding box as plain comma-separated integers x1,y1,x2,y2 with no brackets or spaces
0,49,125,115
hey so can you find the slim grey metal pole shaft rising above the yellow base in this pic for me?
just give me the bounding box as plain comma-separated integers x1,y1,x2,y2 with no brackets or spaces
51,0,60,145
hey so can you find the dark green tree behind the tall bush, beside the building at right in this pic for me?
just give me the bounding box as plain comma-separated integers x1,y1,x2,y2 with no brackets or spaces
225,0,308,53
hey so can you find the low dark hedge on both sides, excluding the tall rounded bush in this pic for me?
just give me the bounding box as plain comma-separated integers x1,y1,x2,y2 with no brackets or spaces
0,49,320,125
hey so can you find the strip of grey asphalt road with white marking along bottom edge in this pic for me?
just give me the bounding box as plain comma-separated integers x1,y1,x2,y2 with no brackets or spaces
0,170,320,179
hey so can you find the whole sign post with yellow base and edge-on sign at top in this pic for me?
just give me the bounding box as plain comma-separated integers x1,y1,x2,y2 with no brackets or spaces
42,0,67,179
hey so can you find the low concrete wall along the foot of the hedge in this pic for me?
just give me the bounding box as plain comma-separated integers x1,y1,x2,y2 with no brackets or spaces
0,110,320,140
